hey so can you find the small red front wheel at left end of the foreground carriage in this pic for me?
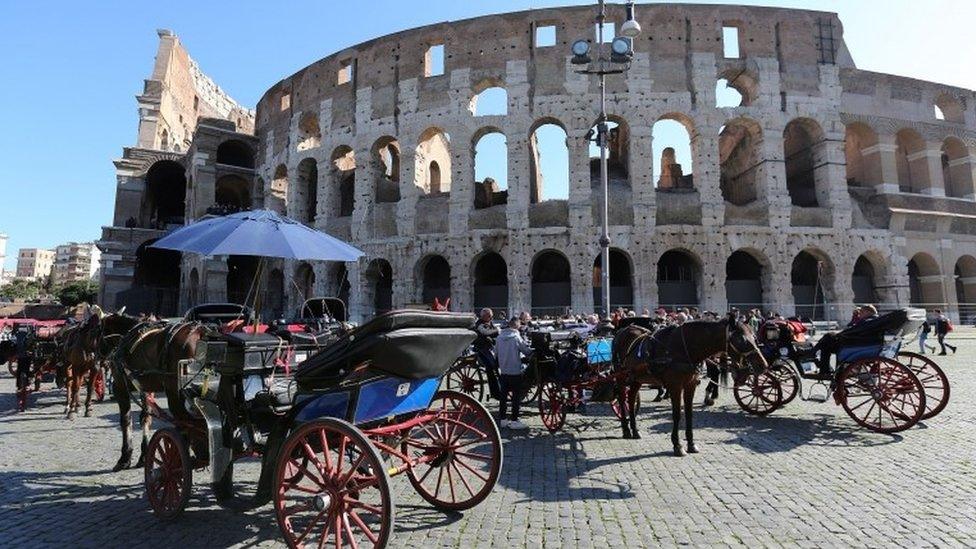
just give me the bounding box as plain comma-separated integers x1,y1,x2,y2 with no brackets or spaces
145,427,193,520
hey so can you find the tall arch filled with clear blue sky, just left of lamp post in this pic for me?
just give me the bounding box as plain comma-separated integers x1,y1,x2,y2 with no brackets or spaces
529,119,569,204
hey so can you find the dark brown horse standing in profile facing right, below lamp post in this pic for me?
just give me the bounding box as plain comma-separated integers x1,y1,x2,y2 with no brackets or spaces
611,316,768,456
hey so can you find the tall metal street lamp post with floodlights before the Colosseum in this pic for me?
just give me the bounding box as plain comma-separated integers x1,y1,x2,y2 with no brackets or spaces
572,0,641,318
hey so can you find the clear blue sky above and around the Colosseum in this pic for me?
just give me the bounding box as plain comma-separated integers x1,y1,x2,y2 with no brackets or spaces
0,0,976,268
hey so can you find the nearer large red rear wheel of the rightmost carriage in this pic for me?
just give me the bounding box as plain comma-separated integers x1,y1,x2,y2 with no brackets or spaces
835,357,925,433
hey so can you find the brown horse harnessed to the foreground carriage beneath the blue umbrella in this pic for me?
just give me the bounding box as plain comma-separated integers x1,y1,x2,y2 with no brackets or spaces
110,322,208,471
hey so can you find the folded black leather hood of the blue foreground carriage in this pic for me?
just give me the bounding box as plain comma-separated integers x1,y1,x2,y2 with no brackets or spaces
295,310,476,388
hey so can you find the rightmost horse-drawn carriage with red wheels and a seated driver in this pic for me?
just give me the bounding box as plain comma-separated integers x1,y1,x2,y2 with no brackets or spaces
735,309,949,433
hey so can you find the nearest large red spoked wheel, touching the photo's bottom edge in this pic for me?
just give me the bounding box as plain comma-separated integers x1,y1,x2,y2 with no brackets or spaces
274,418,394,548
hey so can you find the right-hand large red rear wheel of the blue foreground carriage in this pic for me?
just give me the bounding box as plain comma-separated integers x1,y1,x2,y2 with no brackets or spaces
401,391,502,511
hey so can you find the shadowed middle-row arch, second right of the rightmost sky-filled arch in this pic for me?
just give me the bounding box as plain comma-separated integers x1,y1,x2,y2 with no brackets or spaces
783,119,827,208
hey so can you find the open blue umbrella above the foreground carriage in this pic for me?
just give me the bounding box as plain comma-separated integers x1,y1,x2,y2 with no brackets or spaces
151,210,363,261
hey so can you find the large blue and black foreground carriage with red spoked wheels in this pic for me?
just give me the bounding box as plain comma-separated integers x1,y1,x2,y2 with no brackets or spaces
139,311,502,547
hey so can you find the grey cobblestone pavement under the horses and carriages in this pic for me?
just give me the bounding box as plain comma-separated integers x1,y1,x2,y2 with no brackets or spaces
0,339,976,549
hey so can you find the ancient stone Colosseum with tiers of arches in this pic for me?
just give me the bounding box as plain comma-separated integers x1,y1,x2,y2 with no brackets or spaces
100,4,976,319
